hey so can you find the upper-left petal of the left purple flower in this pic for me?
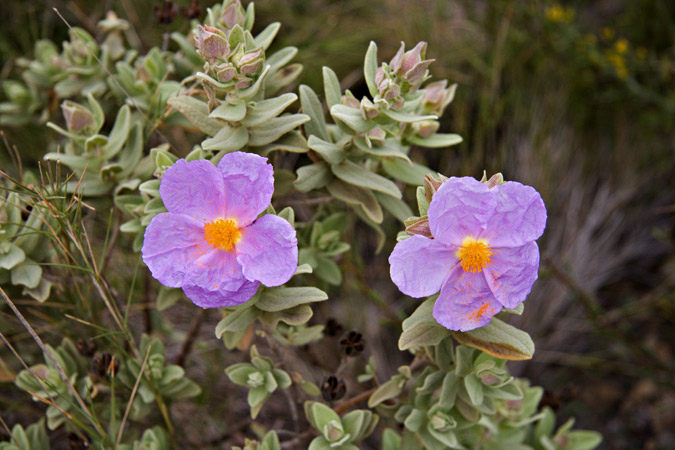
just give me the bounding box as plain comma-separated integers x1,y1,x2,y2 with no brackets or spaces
159,159,225,223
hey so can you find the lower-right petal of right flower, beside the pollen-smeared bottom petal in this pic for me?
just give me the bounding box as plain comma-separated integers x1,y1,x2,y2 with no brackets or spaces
483,242,539,309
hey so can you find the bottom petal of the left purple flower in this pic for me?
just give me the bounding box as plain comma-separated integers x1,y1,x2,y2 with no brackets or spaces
183,248,258,308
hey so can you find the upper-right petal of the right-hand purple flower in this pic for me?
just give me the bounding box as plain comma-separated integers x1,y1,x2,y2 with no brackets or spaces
483,181,546,248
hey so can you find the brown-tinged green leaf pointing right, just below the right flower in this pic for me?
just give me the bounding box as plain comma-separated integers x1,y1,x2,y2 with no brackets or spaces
452,318,534,361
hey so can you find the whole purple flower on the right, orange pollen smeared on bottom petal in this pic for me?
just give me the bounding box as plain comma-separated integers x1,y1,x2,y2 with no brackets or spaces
389,177,546,331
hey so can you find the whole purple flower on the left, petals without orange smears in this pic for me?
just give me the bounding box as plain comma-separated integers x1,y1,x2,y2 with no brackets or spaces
142,152,298,308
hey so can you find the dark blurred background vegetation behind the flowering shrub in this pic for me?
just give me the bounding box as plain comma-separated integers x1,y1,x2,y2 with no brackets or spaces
0,0,675,449
